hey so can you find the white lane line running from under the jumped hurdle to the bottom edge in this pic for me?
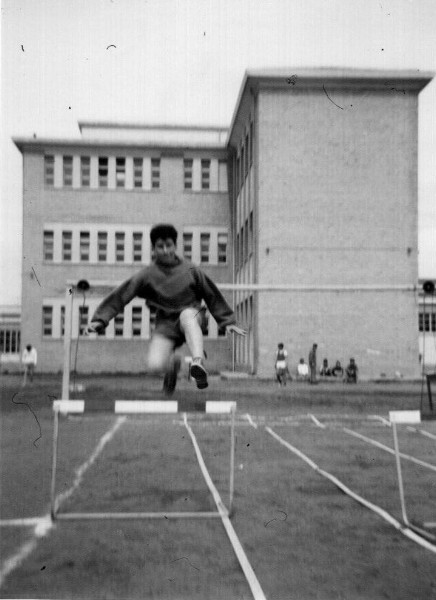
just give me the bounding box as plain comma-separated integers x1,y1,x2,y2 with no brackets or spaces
183,413,266,600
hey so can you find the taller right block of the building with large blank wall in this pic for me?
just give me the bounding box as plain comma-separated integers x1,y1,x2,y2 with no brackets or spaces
228,69,431,377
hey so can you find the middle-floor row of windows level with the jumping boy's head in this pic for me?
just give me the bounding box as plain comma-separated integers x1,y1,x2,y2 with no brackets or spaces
43,223,228,265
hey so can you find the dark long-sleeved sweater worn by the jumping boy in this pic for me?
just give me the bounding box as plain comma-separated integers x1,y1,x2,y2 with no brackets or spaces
91,257,236,327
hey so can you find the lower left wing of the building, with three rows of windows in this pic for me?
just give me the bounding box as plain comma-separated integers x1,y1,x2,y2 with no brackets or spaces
15,123,232,372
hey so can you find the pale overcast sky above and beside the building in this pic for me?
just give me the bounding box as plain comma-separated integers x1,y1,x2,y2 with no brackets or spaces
0,0,436,304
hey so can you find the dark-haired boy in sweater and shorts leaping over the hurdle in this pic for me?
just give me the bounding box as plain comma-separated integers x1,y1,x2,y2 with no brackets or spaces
86,224,246,395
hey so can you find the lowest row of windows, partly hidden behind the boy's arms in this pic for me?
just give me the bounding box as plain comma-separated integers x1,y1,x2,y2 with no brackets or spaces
42,299,225,339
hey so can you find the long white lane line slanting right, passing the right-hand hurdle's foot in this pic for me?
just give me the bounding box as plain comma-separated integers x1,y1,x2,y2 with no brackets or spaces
265,427,436,554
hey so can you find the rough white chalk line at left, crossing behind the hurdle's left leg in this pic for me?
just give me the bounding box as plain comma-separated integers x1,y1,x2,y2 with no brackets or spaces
0,416,126,587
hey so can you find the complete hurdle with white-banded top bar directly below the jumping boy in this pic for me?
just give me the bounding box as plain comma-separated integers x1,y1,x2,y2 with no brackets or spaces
50,400,237,521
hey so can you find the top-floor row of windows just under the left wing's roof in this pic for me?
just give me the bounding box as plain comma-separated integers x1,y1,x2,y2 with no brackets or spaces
44,154,227,191
